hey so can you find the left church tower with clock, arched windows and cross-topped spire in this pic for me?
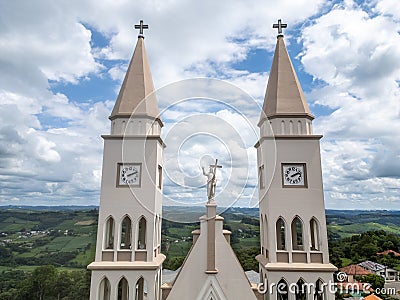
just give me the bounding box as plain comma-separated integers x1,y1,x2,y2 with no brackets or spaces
88,21,165,300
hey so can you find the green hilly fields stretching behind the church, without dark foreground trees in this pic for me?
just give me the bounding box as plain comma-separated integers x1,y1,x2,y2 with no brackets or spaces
0,207,400,272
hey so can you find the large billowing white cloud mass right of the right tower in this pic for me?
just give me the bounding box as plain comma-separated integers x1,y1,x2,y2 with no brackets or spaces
300,1,400,208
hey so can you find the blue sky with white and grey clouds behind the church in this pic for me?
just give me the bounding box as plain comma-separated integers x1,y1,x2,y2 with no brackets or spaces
0,0,400,209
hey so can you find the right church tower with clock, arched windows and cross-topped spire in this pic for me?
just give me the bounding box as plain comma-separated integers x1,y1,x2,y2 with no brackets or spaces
256,20,336,299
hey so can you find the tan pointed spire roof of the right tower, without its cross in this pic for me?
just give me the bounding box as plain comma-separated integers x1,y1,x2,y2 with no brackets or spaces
261,34,314,120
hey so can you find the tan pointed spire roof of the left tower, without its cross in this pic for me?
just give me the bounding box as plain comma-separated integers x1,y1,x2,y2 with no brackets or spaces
110,35,160,119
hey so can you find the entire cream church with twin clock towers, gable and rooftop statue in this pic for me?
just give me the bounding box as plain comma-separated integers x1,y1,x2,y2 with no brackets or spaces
88,20,337,300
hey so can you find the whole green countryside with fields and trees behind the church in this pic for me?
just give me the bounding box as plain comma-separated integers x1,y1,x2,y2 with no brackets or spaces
0,206,400,299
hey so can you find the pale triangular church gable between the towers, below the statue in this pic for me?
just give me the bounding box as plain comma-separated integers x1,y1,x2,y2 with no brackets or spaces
166,212,256,300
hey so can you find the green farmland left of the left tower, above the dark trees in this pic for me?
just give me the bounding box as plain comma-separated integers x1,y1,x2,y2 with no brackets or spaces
0,209,97,270
